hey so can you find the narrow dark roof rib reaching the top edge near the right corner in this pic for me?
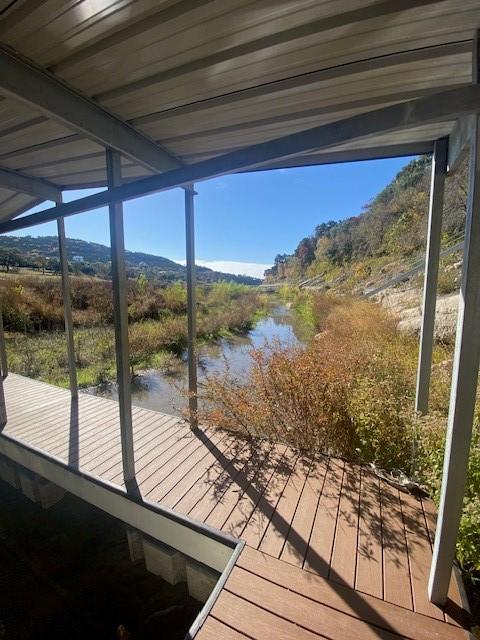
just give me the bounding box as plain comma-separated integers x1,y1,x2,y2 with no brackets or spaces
96,0,446,100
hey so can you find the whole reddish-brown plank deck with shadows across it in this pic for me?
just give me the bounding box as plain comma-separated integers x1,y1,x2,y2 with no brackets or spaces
0,374,469,640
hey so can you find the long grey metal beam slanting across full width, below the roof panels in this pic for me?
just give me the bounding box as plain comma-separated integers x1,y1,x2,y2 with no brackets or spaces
0,85,480,233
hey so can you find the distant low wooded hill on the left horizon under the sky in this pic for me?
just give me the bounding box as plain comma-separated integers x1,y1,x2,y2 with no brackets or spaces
0,236,261,285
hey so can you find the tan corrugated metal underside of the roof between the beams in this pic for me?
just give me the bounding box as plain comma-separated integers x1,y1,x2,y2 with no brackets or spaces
0,0,480,204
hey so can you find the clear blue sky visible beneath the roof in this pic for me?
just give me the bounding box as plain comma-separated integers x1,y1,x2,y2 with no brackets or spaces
16,158,411,274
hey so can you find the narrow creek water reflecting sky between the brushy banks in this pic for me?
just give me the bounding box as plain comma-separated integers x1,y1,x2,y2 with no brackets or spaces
91,305,309,415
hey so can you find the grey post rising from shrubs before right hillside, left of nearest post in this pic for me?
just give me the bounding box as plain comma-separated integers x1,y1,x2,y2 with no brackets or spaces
415,138,447,414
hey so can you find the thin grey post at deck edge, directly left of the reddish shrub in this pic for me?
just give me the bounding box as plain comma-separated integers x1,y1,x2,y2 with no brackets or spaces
185,185,198,429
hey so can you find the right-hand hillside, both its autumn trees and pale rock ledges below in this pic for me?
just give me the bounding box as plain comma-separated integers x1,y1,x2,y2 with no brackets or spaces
265,157,467,340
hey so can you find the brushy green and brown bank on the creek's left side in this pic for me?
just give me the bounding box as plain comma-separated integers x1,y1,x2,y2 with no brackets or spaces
3,280,268,387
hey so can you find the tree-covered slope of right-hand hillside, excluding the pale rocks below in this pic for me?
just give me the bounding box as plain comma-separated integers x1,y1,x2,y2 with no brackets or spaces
265,157,467,292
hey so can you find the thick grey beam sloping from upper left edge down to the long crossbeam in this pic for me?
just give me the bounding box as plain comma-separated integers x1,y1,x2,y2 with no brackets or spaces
0,45,181,171
